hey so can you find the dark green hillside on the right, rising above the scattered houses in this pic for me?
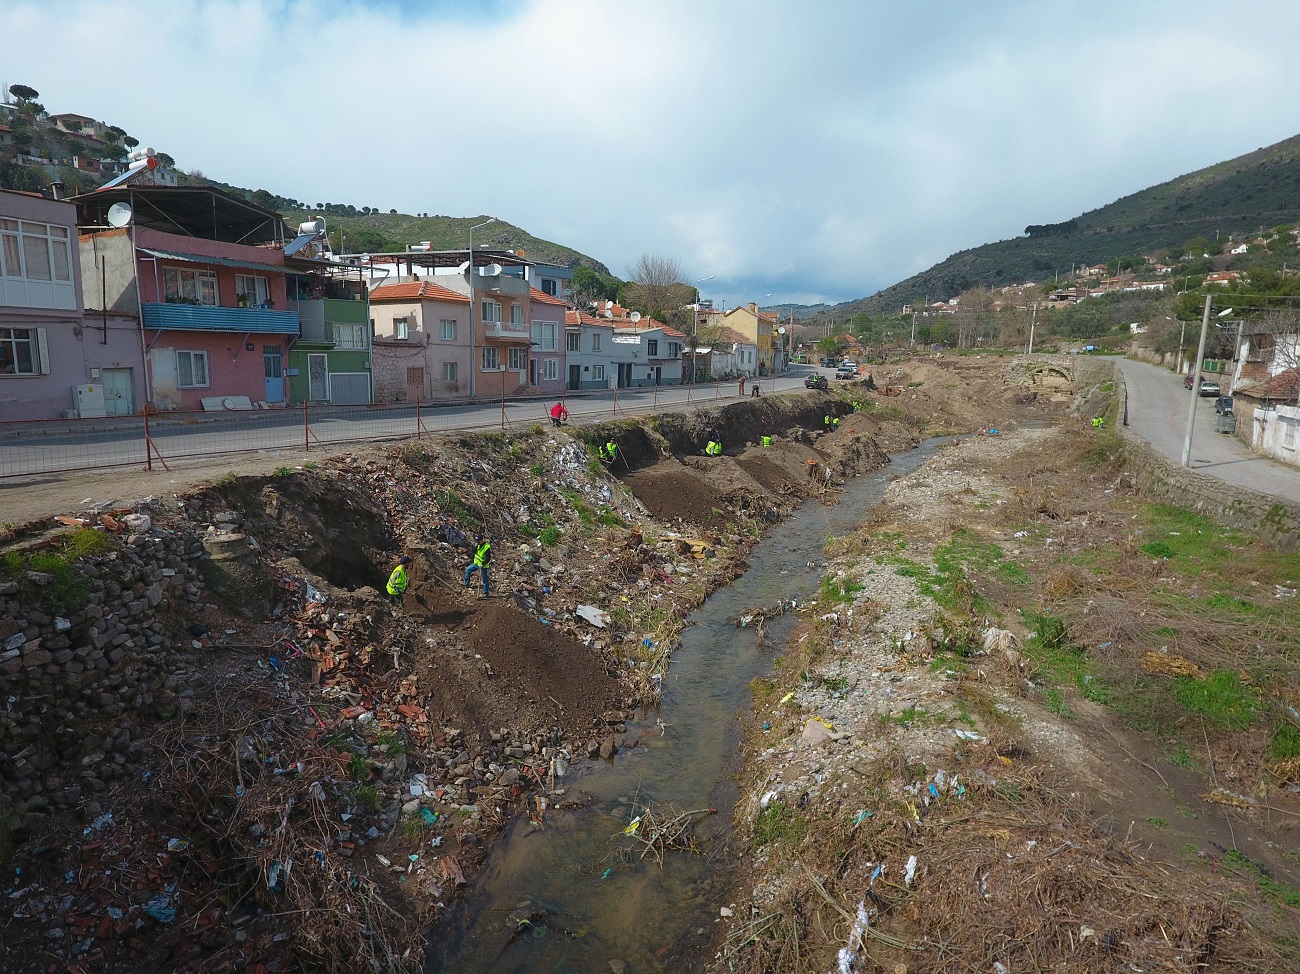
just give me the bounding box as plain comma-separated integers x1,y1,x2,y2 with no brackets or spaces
835,135,1300,317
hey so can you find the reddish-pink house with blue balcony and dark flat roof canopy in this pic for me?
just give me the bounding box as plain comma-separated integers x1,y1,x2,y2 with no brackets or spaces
73,185,299,410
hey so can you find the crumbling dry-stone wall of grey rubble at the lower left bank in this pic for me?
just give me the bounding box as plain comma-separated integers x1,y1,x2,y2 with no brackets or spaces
0,528,204,831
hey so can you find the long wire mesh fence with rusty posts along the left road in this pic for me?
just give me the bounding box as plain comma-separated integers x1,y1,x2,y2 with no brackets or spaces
0,376,802,477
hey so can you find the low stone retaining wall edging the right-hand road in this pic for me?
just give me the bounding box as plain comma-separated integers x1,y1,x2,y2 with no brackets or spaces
1115,369,1300,551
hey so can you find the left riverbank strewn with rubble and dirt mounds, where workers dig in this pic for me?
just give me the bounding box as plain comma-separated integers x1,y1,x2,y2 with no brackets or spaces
0,353,1066,970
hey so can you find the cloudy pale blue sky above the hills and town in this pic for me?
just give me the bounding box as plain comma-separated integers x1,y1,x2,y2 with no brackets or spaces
0,0,1300,307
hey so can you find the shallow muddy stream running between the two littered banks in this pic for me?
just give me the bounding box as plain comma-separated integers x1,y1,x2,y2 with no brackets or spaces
428,441,940,974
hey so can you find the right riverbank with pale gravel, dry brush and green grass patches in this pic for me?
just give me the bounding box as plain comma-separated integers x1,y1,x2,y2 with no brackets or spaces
711,423,1300,973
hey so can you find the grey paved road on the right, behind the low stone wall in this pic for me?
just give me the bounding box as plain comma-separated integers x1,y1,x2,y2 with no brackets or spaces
1115,359,1300,503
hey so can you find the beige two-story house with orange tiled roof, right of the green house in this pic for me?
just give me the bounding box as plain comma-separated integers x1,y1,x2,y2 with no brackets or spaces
371,278,471,402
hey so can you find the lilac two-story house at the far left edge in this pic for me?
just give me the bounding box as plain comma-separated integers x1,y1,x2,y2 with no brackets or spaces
0,191,143,420
